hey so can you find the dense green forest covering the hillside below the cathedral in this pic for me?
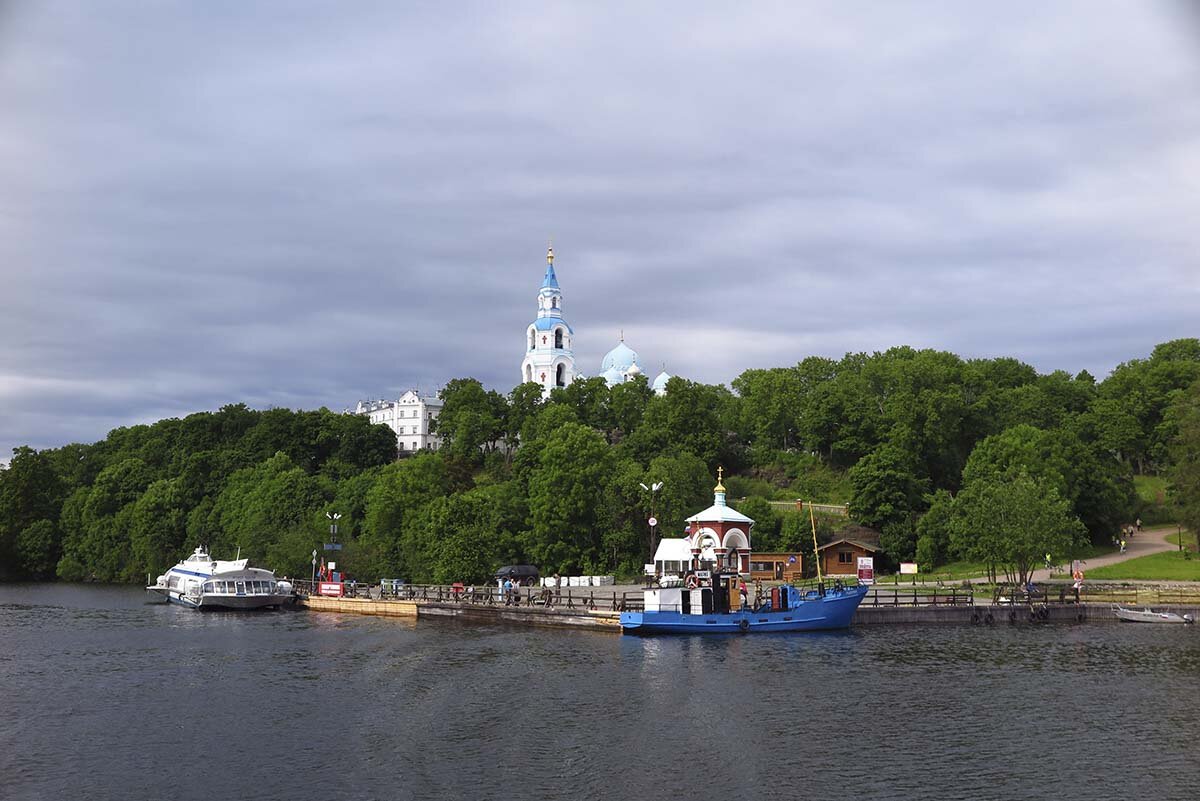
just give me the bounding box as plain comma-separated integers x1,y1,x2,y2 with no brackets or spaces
0,339,1200,582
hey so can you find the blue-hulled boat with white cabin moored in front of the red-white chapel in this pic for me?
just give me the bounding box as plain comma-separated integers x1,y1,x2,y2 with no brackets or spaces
620,577,868,634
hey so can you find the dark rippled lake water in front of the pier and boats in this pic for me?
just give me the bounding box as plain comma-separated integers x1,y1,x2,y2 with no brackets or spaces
0,585,1200,800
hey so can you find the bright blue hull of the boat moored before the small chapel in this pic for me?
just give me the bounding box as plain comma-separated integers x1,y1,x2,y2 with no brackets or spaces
620,586,868,634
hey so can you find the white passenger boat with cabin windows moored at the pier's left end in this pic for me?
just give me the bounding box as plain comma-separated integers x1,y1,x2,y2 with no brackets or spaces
146,547,295,609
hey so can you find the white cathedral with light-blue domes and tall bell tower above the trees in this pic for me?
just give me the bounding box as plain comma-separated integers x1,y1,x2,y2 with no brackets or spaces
521,247,671,397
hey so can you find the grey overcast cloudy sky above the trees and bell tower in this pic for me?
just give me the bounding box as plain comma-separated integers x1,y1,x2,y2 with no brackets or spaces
0,0,1200,456
